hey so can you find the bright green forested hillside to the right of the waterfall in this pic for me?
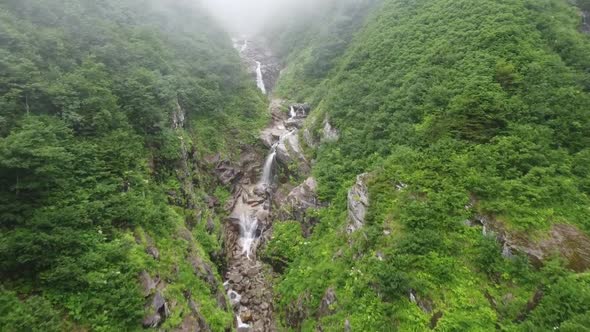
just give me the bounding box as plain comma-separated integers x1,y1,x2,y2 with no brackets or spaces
267,0,590,331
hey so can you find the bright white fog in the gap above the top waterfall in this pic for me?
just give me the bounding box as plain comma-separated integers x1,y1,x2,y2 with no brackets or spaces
201,0,332,35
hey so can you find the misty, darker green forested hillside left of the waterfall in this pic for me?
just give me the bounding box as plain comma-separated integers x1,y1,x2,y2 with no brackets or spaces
0,0,266,331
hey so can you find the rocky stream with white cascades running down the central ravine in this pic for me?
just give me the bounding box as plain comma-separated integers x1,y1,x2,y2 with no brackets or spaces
224,39,296,332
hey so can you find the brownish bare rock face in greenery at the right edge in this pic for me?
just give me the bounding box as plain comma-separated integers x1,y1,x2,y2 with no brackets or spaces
468,216,590,272
